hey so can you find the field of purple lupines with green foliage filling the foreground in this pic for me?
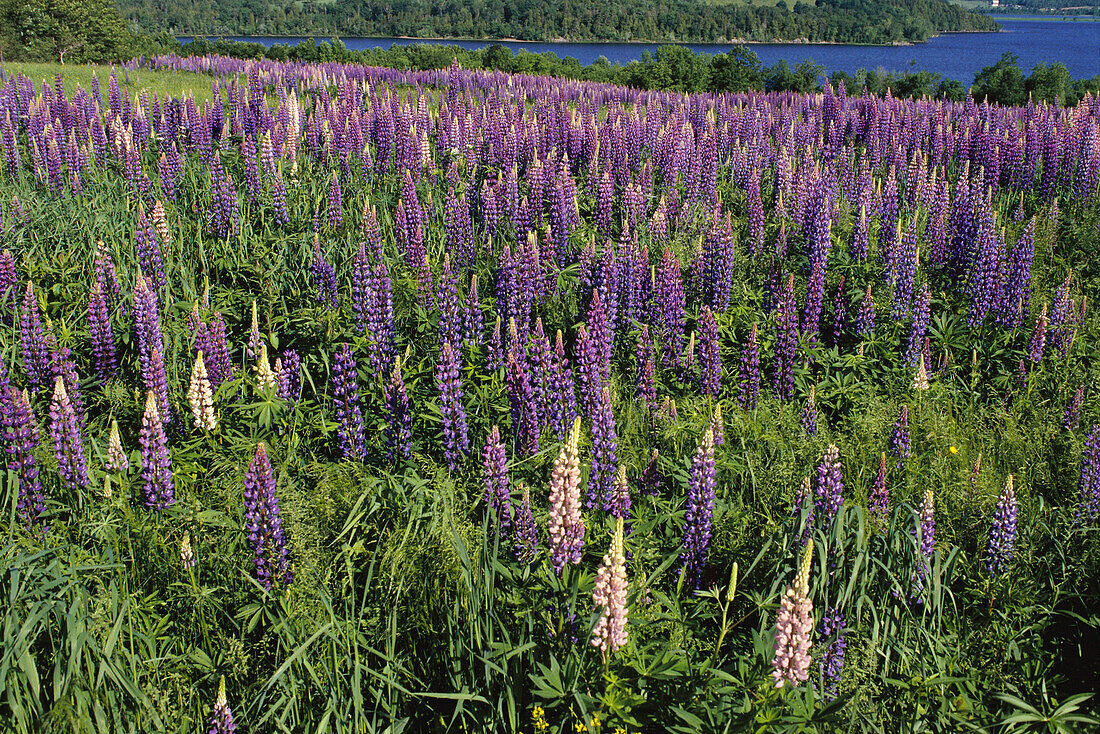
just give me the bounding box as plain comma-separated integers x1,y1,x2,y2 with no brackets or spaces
0,57,1100,734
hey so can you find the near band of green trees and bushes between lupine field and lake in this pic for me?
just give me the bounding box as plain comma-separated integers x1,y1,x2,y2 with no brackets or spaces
0,0,1100,106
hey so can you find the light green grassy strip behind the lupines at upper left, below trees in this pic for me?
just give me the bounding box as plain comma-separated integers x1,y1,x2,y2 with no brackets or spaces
2,62,213,105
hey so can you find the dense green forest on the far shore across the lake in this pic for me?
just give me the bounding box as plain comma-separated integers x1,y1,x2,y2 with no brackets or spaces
119,0,997,43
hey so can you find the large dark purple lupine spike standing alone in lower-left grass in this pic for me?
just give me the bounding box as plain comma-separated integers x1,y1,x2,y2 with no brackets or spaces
244,441,293,589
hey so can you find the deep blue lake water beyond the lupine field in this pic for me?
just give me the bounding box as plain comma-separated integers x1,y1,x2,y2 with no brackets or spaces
182,18,1100,85
